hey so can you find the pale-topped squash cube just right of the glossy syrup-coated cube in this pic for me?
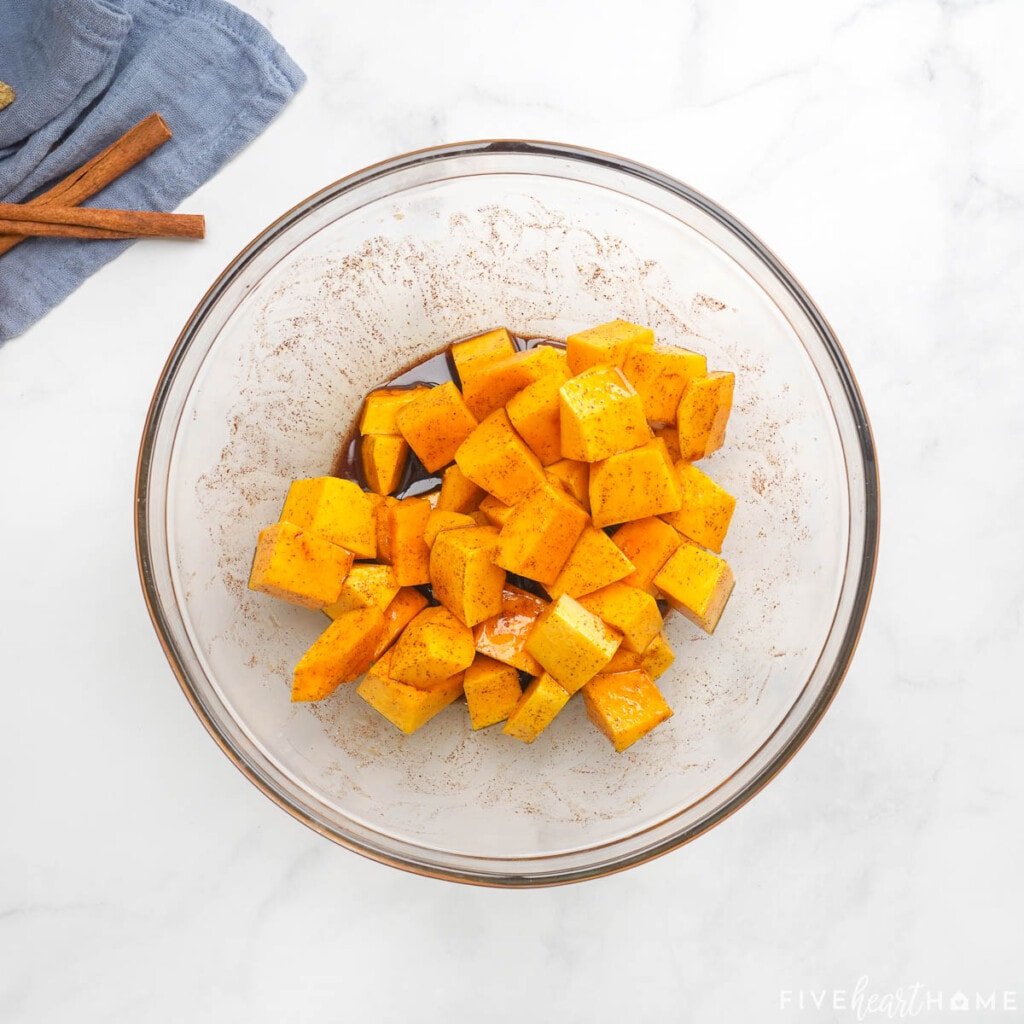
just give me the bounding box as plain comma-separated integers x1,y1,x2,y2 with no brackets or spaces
526,594,623,693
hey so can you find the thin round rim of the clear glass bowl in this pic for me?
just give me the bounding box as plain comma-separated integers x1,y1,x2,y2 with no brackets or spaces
133,138,881,888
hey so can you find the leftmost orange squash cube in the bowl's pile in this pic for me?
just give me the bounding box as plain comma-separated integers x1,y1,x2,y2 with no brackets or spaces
249,522,352,608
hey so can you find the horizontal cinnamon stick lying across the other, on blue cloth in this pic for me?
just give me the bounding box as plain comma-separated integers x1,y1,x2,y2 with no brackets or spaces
0,203,206,239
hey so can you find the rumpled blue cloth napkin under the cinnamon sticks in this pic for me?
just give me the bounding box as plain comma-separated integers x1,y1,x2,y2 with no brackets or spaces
0,0,305,343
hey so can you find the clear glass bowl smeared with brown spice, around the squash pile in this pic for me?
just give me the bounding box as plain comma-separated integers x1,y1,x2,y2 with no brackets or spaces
136,141,879,886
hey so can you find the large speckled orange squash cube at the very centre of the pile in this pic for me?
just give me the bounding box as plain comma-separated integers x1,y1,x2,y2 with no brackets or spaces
495,483,587,584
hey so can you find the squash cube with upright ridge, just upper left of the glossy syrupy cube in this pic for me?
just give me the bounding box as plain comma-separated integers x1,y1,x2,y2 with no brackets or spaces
430,526,505,622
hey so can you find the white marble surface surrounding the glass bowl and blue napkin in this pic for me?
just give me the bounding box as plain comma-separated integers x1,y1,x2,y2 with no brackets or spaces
0,0,1024,1024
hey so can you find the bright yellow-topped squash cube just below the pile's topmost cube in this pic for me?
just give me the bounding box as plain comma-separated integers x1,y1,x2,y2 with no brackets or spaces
558,367,650,462
